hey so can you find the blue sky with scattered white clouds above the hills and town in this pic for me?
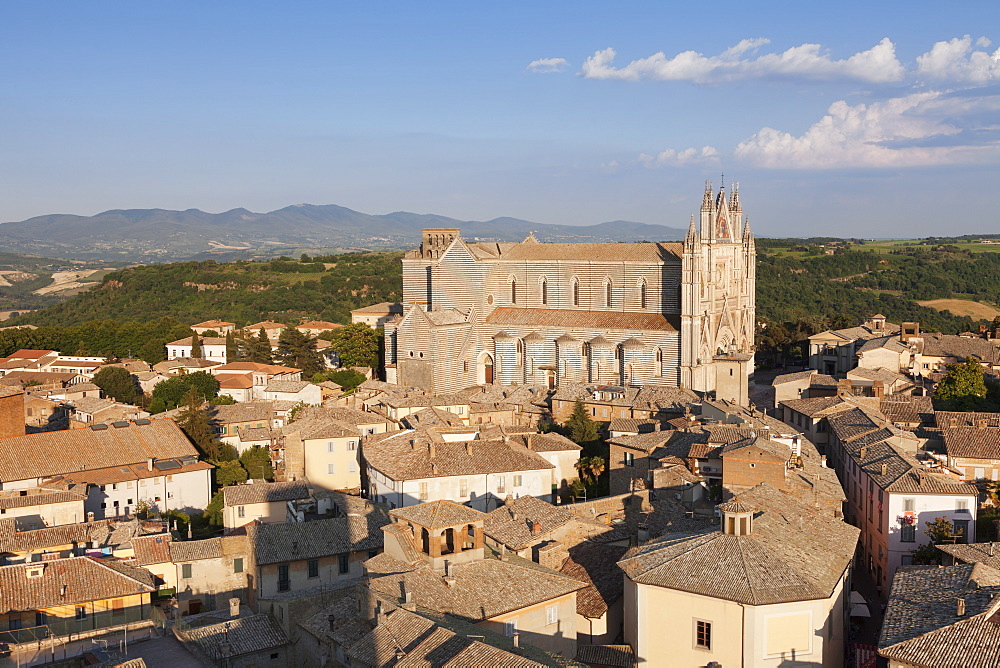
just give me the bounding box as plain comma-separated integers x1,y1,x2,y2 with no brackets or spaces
0,1,1000,237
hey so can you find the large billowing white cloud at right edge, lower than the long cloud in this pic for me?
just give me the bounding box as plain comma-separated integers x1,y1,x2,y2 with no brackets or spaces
735,91,1000,169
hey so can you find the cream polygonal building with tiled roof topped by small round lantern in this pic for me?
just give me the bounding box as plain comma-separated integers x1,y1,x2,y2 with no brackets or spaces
618,483,858,668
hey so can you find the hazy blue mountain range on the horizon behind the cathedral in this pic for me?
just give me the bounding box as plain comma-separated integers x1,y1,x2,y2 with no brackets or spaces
0,204,686,263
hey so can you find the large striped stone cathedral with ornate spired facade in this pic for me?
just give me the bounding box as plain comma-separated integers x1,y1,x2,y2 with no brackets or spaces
385,184,756,404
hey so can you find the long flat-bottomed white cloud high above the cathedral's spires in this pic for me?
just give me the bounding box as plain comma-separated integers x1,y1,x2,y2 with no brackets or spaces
580,37,904,83
